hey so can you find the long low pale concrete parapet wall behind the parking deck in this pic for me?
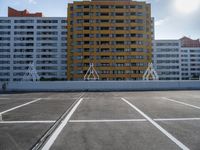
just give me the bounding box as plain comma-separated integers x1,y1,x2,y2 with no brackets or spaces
7,81,200,91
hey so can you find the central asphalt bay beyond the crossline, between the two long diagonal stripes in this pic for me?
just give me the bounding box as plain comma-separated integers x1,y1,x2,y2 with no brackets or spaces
72,96,145,120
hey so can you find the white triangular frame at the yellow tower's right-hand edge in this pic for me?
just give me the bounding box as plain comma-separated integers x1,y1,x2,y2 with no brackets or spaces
143,63,159,80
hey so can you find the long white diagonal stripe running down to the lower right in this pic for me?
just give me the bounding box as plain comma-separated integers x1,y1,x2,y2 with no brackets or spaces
121,98,189,150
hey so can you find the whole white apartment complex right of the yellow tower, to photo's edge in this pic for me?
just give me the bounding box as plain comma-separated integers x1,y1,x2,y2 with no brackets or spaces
153,37,200,80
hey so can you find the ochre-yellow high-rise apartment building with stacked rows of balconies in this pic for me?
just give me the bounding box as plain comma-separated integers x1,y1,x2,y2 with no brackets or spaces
67,0,152,80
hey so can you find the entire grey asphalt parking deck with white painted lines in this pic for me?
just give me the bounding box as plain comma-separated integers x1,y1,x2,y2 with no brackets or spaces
0,91,200,150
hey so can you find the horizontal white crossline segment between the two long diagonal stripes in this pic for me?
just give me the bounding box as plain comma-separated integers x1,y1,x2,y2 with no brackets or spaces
69,119,147,123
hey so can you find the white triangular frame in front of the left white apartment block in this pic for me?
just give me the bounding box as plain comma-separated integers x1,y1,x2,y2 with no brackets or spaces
22,63,40,82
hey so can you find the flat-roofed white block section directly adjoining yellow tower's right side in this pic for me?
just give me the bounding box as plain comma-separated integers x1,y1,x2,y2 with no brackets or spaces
153,40,181,80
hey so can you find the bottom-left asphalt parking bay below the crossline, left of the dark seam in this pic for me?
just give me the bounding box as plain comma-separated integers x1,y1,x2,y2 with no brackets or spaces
0,123,52,150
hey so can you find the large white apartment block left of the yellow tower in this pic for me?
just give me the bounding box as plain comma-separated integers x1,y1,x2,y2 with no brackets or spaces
0,17,67,82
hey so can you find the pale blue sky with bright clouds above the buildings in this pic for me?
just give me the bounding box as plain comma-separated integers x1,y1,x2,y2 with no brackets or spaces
0,0,200,39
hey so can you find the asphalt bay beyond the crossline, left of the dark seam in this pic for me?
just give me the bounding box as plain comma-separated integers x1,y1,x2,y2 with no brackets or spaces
2,99,75,121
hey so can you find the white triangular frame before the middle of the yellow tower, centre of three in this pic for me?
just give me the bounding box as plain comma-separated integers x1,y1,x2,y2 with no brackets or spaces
84,63,99,80
